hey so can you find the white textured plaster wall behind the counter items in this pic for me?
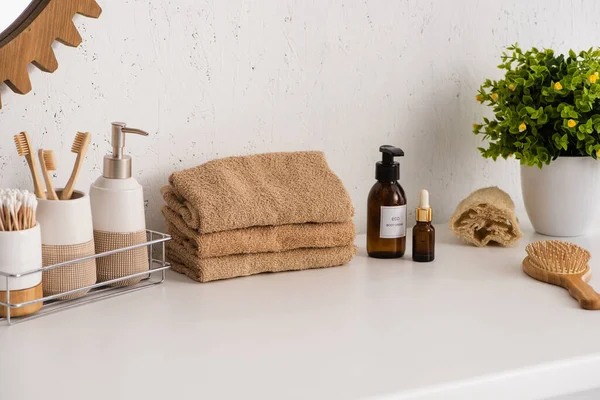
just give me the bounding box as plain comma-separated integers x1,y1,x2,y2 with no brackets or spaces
0,0,600,230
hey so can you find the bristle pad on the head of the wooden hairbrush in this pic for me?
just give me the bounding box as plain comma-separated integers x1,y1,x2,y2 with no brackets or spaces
525,240,591,274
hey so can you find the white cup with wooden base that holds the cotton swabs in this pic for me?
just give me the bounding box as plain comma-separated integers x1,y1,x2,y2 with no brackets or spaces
0,224,42,317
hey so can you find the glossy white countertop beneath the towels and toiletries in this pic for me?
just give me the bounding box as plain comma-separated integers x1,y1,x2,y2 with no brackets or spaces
0,226,600,400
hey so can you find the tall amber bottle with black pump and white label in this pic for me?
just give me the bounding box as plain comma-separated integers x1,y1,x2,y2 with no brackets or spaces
367,146,406,258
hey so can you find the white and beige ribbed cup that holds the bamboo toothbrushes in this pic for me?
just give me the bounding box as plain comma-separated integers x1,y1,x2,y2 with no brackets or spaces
37,189,96,299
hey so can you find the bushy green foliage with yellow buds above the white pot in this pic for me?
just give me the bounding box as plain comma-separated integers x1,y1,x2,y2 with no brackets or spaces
473,44,600,167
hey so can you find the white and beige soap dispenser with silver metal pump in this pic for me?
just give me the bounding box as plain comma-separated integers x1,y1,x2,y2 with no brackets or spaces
90,122,149,286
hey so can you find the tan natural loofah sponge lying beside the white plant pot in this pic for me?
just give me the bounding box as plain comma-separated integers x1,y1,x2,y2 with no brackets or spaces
450,187,523,247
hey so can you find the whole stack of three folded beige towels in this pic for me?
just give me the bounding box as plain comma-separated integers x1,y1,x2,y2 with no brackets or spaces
161,151,356,282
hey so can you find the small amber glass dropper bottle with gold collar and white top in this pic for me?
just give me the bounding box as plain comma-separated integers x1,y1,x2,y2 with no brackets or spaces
413,190,435,262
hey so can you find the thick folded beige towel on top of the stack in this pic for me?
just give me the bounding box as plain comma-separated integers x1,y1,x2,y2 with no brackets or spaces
161,151,354,234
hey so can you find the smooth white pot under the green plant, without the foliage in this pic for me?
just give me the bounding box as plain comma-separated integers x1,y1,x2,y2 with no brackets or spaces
521,157,600,236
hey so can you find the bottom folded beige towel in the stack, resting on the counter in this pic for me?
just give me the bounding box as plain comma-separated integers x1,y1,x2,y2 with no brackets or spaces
166,240,356,282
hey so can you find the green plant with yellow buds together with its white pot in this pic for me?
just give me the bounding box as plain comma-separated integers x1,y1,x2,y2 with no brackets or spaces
473,44,600,236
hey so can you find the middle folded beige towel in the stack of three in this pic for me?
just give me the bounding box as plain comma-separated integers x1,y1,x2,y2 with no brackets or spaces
162,206,356,258
